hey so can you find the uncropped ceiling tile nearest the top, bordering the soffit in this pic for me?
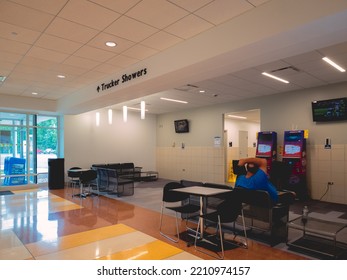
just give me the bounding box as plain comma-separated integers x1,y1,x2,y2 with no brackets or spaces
165,15,214,39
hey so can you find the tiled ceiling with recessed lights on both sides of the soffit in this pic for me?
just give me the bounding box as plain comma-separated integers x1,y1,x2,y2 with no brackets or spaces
0,0,347,114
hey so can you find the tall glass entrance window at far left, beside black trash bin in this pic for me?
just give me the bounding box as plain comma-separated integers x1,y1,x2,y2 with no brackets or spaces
0,112,59,186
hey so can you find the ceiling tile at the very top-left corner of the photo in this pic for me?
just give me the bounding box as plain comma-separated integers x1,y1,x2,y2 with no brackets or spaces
0,1,54,32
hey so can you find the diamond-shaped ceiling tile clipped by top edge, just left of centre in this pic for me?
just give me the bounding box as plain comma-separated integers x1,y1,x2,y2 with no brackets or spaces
126,0,188,29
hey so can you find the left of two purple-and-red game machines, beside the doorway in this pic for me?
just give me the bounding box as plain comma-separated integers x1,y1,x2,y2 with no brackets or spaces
255,131,277,174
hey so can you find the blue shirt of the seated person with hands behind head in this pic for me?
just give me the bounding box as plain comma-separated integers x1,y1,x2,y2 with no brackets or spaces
235,169,278,202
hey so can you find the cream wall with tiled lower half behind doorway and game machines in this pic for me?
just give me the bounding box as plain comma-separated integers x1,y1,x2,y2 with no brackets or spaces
157,83,347,204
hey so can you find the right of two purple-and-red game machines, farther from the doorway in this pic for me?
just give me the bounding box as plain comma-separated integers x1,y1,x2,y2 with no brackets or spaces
282,130,307,199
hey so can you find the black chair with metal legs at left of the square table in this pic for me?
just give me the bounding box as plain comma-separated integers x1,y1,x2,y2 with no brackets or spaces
159,182,200,243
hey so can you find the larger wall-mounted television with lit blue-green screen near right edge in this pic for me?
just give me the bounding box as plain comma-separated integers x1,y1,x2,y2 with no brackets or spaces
312,97,347,122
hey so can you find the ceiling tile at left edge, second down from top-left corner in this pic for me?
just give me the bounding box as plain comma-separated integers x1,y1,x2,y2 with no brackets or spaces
0,22,41,44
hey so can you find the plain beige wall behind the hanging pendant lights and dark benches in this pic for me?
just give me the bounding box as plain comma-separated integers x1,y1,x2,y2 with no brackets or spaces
64,109,156,179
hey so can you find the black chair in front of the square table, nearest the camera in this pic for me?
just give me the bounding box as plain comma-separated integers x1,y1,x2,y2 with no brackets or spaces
194,191,248,259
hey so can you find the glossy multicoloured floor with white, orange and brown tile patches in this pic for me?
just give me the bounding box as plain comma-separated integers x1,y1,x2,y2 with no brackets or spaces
0,186,305,260
